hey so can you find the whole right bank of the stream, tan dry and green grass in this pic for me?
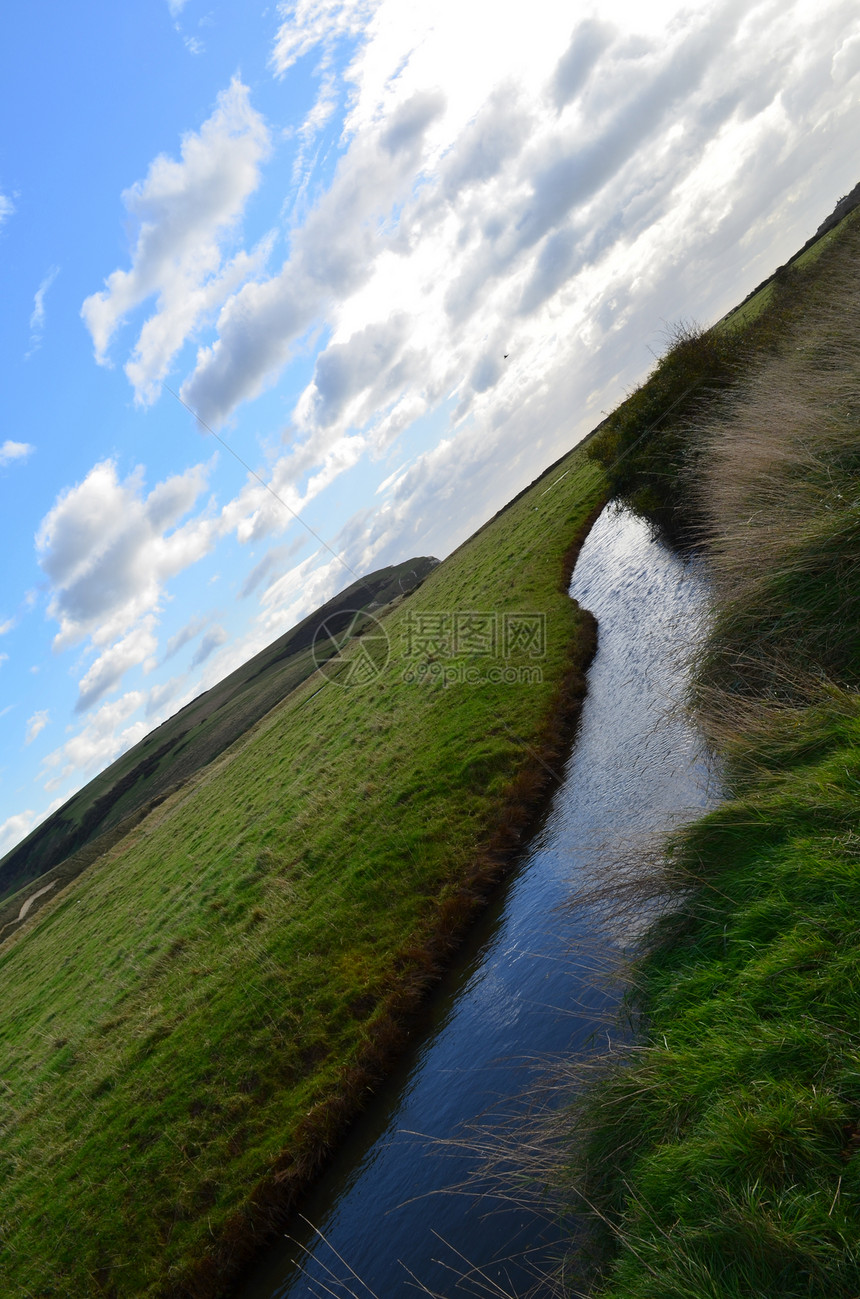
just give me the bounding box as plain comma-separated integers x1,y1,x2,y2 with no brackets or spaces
570,221,860,1299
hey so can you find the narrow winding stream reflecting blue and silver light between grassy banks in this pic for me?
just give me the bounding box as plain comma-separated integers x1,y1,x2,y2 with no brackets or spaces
236,507,718,1299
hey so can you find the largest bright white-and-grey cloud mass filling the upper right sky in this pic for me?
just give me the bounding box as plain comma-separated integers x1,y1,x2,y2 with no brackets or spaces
144,0,854,601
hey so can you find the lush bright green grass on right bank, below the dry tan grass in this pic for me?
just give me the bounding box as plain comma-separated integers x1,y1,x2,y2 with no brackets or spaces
588,716,860,1299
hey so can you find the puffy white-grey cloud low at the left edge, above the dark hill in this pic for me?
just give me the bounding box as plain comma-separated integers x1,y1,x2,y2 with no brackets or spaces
36,460,217,654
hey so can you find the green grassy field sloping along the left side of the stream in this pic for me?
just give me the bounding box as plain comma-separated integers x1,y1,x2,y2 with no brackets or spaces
0,451,605,1299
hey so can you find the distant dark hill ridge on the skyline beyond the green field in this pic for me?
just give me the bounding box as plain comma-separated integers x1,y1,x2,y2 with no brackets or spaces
0,559,436,929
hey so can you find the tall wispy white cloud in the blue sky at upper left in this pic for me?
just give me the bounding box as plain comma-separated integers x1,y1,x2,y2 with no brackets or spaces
81,78,270,401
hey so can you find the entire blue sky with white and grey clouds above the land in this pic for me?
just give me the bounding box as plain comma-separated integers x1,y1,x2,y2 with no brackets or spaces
0,0,860,851
